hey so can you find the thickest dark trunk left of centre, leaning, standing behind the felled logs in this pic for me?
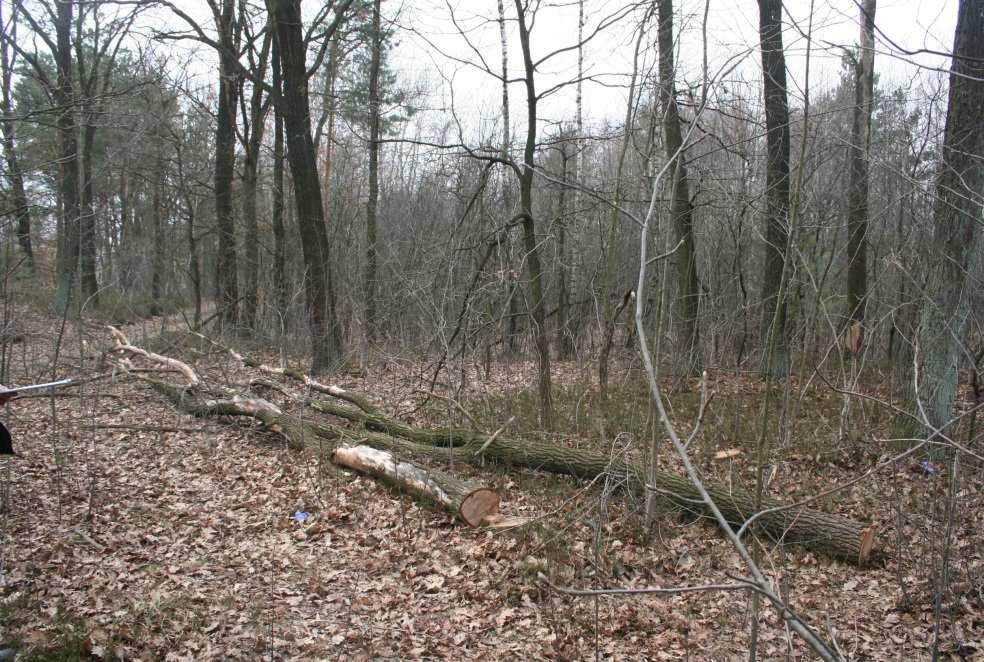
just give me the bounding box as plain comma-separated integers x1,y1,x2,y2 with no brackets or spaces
267,0,342,374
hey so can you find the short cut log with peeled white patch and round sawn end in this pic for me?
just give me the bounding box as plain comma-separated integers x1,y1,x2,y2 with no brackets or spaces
332,445,499,526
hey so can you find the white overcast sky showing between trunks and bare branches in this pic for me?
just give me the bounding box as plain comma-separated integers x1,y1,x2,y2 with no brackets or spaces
140,0,958,136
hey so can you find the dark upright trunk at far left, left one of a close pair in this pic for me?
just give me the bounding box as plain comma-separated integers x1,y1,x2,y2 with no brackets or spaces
54,2,80,315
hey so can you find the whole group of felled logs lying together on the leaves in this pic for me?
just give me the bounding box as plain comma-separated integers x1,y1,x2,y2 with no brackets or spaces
107,330,874,565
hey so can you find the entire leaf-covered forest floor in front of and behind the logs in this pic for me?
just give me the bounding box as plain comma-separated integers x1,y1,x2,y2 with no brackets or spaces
0,304,984,660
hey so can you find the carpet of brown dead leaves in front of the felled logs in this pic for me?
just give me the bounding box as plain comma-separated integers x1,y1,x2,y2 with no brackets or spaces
0,320,984,660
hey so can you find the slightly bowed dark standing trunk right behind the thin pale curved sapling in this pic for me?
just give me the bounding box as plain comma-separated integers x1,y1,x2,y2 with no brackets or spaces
657,0,703,375
